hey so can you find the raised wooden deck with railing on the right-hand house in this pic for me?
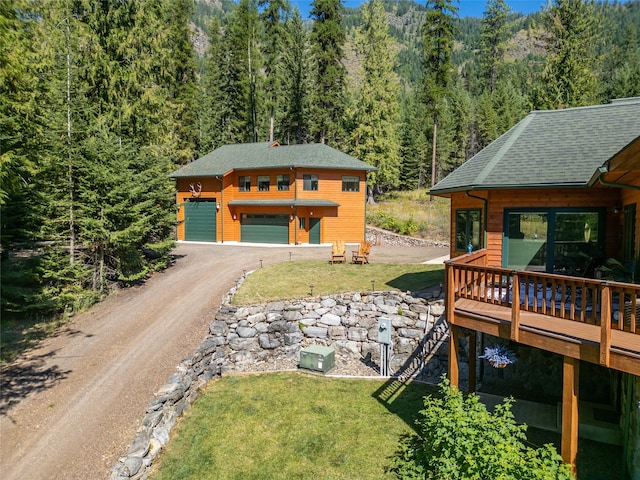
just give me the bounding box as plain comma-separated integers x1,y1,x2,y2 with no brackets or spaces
447,251,640,375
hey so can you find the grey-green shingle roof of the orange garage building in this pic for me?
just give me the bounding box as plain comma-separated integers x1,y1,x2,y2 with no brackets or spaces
170,142,375,178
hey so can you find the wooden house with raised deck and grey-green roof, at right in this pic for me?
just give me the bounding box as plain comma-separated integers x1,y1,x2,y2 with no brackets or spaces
431,98,640,480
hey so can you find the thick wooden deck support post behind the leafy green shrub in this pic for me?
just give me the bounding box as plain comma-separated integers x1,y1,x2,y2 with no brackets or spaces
561,356,580,475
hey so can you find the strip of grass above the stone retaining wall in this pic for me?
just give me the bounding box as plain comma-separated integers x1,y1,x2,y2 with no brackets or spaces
233,260,444,305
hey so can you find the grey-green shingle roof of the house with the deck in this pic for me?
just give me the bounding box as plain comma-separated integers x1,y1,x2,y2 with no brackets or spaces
431,98,640,194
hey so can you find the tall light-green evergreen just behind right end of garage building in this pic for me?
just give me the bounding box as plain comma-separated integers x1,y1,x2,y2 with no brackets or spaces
351,0,400,196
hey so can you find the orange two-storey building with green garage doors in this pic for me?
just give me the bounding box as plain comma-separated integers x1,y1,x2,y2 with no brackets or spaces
171,142,375,244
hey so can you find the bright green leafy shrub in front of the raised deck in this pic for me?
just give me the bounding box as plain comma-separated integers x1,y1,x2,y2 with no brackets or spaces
389,380,574,480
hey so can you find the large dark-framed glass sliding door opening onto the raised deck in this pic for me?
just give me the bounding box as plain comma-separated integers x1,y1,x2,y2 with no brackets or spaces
503,208,605,277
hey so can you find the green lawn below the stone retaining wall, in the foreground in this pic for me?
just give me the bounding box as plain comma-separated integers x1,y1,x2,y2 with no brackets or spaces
150,372,437,480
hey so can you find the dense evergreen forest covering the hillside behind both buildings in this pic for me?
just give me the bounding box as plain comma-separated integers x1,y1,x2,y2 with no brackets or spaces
0,0,640,318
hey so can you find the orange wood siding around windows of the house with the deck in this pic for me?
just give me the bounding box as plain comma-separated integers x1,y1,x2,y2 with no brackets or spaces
450,187,624,267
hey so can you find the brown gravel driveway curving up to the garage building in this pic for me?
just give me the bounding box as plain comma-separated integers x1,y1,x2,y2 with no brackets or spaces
0,244,447,480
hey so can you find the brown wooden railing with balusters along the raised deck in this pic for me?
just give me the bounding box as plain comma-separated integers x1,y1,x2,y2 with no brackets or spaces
446,250,640,364
